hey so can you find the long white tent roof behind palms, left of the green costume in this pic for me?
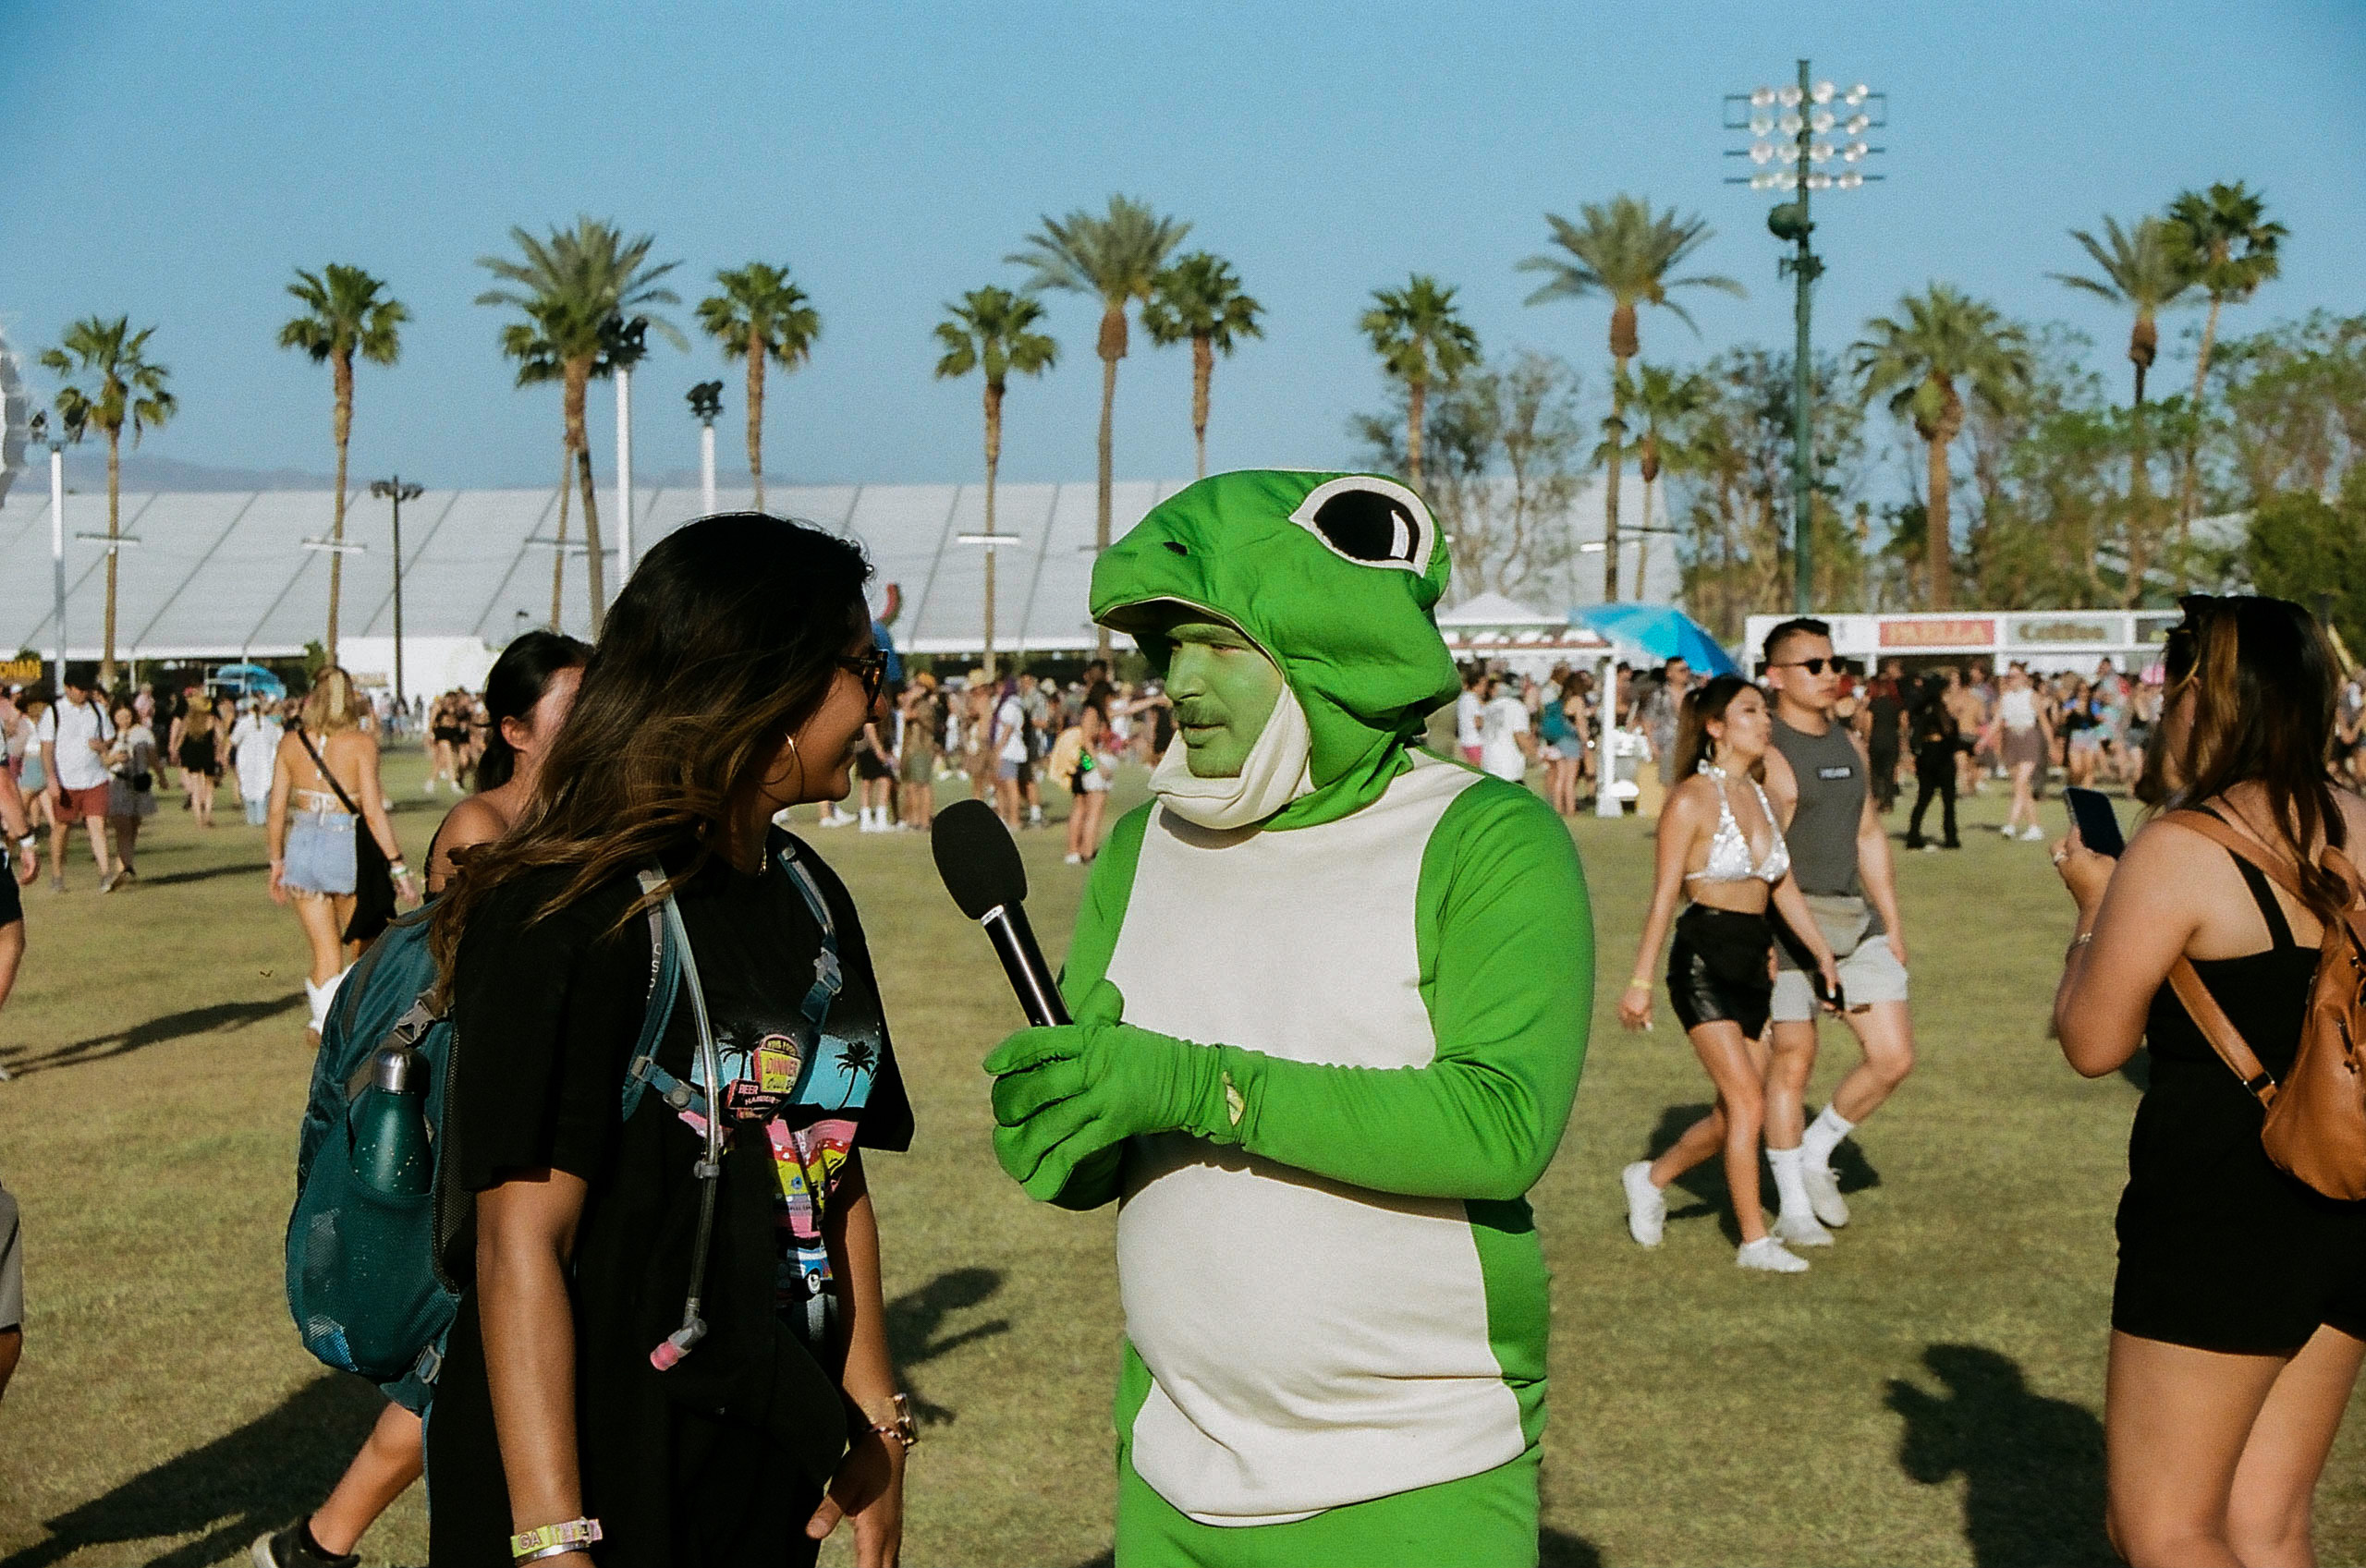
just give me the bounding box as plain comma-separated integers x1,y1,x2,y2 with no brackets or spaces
0,480,1183,660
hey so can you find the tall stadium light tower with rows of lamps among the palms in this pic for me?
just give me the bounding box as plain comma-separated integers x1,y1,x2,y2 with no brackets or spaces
1725,59,1890,613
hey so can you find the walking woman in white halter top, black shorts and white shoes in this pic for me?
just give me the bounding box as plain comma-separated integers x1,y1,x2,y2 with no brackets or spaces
1618,674,1841,1275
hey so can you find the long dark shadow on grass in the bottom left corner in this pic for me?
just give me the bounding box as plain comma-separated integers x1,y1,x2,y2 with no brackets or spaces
0,1374,385,1568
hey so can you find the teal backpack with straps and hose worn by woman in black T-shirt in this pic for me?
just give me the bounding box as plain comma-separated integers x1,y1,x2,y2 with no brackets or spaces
287,845,842,1412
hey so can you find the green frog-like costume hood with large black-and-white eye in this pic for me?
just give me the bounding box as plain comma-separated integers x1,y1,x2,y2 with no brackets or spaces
1093,468,1460,828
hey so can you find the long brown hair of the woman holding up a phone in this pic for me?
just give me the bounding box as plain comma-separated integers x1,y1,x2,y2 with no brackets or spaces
2163,593,2349,920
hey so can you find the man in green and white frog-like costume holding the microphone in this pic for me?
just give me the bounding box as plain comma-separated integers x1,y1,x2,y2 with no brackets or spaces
987,470,1592,1568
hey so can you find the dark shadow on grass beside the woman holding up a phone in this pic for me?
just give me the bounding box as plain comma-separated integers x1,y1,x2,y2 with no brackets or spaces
1883,1345,2120,1568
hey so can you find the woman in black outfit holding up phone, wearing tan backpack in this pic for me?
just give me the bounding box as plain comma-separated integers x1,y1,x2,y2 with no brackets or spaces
2054,593,2366,1568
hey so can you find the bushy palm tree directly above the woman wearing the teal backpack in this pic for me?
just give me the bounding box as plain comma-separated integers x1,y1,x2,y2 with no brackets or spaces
476,217,689,637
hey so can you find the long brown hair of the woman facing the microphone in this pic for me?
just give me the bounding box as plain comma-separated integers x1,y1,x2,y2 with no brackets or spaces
428,511,871,998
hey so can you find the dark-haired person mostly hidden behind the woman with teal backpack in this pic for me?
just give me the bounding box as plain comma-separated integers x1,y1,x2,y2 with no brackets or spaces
249,629,592,1568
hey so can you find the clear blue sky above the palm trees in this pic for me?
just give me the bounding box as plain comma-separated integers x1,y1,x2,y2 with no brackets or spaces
0,0,2366,485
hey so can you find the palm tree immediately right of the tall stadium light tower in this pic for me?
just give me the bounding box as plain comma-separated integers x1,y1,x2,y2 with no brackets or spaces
1850,284,2030,610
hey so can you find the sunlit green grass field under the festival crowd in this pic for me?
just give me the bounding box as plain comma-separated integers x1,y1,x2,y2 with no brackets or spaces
0,755,2366,1568
